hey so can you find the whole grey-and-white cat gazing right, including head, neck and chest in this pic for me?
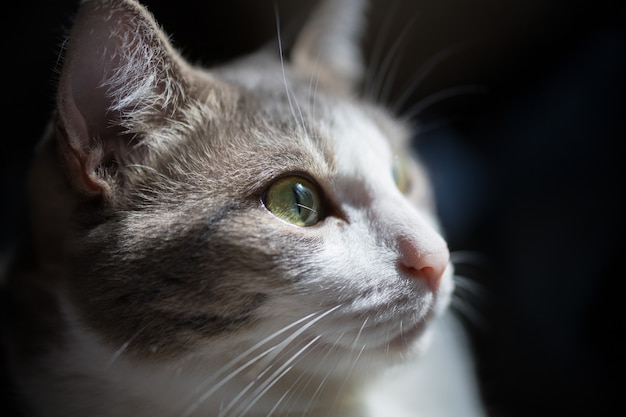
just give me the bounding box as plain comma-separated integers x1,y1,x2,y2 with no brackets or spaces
4,0,485,417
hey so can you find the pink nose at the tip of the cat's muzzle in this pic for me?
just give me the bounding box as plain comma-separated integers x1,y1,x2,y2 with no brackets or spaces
398,239,450,291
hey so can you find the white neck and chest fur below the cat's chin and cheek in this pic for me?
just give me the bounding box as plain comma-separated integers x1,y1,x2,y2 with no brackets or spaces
14,282,483,417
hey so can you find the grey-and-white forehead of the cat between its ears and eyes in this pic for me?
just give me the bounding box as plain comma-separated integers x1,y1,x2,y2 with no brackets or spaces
154,50,409,200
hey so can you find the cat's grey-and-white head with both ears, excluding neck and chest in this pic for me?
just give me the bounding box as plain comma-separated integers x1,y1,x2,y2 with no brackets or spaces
34,0,452,376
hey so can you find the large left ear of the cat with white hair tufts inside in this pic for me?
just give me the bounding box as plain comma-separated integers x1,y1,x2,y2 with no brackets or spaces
57,0,185,195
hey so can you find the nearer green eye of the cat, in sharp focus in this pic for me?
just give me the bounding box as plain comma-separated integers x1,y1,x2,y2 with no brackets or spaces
264,177,321,226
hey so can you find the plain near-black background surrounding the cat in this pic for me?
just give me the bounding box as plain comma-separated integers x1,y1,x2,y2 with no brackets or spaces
0,0,626,417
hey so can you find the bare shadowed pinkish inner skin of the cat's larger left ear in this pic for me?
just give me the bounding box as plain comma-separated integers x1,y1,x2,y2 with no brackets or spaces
57,4,132,195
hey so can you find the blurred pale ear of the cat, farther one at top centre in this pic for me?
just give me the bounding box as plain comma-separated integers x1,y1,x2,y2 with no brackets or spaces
292,0,367,93
